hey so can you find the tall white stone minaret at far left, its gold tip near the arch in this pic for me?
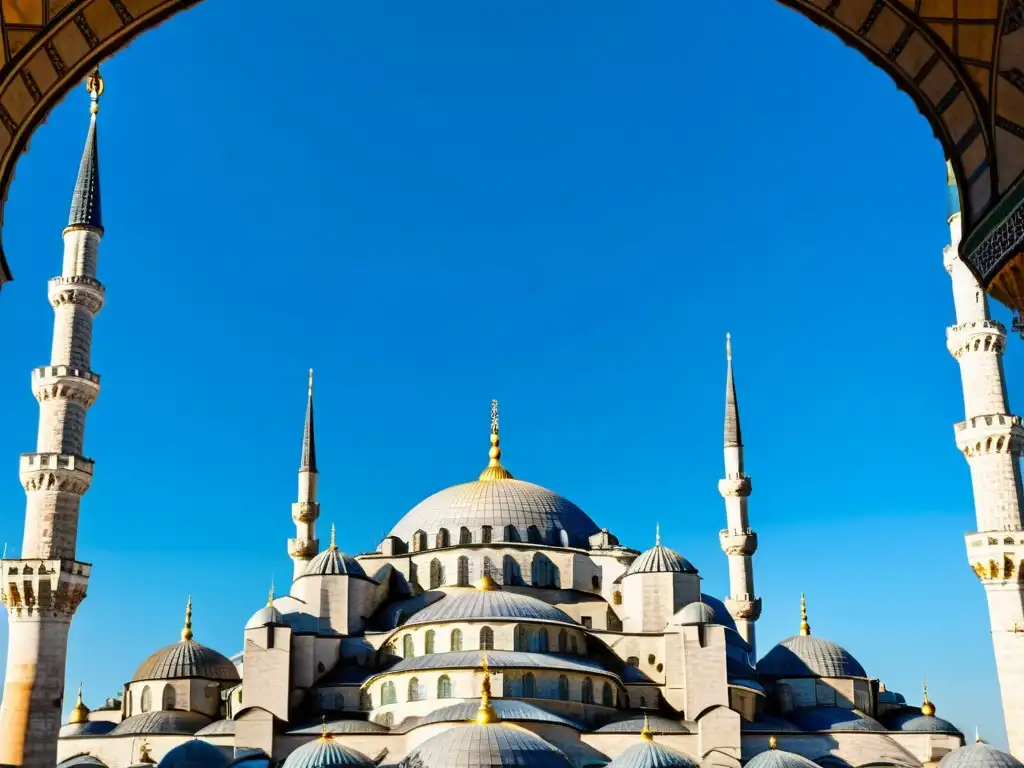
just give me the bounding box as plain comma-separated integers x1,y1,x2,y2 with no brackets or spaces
0,71,103,768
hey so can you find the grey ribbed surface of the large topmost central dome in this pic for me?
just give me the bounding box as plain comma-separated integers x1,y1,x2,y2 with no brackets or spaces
391,480,598,548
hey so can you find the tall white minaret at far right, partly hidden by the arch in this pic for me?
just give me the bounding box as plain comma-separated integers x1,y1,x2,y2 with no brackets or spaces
943,156,1024,759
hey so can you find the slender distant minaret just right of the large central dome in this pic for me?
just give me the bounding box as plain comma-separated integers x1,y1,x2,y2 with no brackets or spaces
718,334,761,653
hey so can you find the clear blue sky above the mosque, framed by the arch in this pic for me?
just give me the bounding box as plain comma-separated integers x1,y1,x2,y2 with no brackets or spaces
0,0,1007,744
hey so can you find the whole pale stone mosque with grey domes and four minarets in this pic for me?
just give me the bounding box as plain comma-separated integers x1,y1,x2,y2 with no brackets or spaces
0,72,1024,768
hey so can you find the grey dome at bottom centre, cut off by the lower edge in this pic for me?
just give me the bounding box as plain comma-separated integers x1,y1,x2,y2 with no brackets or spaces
399,723,570,768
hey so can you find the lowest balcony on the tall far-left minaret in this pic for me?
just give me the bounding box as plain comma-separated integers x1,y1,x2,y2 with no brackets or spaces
0,559,92,617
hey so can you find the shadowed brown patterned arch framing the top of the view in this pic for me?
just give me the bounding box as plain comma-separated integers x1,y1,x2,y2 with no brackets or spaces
0,0,1024,309
